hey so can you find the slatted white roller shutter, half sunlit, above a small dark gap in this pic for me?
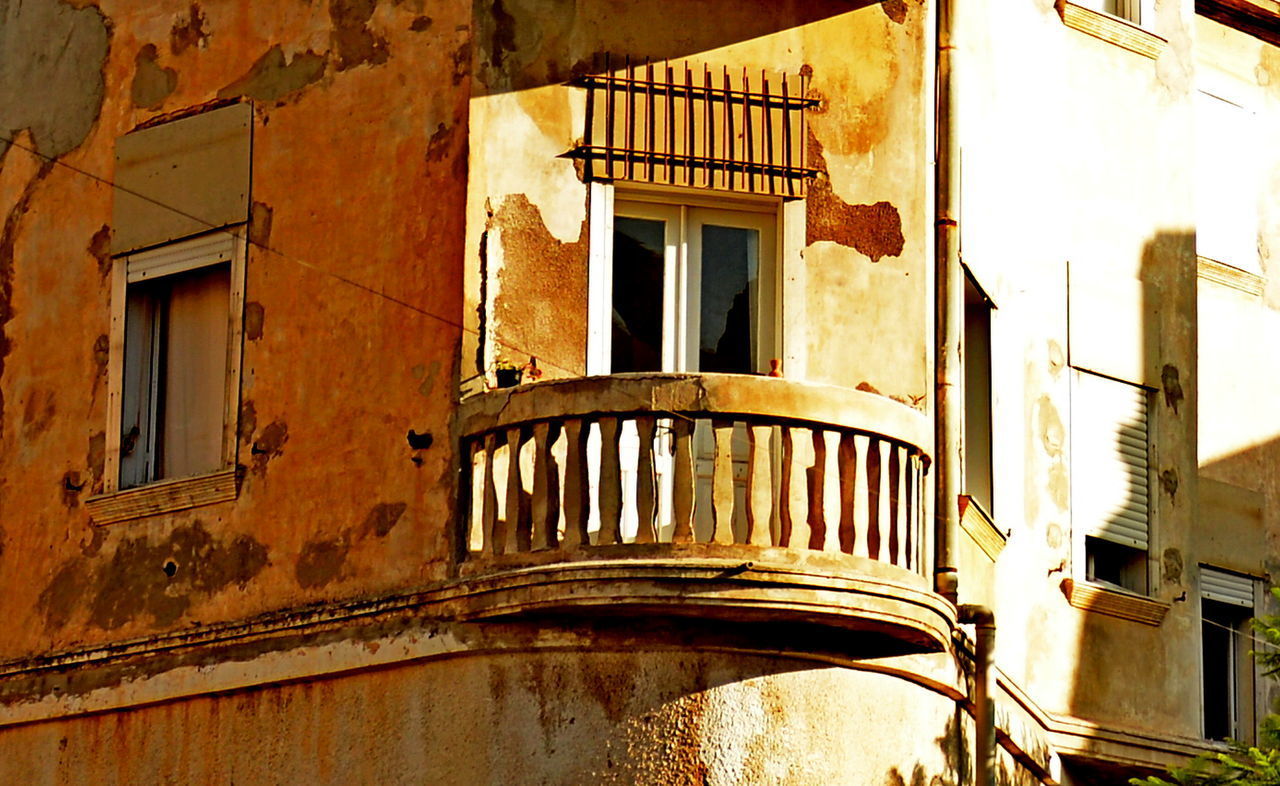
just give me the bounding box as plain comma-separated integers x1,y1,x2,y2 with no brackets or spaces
1071,371,1151,549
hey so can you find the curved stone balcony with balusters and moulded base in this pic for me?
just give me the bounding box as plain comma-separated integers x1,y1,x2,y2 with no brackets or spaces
458,374,955,652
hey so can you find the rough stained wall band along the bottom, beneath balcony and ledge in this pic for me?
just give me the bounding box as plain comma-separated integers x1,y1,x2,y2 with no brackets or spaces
0,648,972,786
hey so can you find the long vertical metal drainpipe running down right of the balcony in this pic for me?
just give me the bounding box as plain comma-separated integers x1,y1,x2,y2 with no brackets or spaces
933,0,964,603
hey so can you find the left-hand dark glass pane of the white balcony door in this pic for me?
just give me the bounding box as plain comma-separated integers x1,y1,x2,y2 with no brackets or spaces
611,216,667,374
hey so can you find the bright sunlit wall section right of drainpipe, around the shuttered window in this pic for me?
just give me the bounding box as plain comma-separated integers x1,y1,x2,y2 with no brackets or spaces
957,0,1199,737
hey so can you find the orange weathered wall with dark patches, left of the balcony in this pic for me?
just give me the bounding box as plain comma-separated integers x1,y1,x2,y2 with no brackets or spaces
0,0,470,659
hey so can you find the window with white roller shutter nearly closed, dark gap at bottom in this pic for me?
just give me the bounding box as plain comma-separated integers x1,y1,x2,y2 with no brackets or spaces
1071,367,1156,595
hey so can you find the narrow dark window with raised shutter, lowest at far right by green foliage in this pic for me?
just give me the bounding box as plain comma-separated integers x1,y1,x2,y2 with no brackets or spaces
1199,565,1261,741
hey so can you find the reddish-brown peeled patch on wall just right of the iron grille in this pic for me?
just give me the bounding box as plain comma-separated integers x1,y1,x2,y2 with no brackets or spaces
805,132,906,262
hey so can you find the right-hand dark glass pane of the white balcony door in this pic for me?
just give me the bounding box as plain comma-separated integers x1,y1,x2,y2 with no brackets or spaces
698,224,760,374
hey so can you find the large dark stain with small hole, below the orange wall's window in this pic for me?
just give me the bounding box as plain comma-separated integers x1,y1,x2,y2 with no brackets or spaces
38,521,269,630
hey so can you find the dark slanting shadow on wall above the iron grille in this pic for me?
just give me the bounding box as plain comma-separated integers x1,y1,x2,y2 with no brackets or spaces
474,0,908,96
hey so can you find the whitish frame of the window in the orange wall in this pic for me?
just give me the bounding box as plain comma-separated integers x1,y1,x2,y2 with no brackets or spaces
102,224,247,494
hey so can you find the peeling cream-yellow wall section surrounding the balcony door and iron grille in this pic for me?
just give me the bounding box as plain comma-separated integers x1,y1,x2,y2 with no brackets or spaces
462,0,931,407
